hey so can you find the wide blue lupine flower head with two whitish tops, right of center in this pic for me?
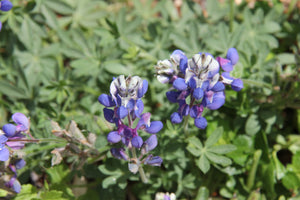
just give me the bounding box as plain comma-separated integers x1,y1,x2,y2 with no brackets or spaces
155,48,243,129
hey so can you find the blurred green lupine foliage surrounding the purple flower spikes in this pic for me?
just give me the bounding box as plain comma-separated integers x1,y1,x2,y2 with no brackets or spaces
0,0,300,200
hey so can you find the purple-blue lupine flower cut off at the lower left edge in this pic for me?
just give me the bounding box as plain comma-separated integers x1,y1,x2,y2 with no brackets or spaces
0,113,30,193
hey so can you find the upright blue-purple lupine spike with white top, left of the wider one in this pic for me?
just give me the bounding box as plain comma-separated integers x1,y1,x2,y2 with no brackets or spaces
98,75,163,173
